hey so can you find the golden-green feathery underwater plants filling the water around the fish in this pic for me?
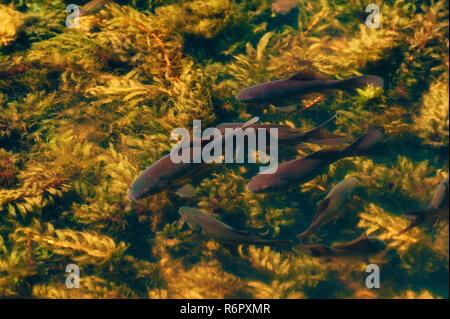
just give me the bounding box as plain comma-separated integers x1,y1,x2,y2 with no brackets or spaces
0,0,449,298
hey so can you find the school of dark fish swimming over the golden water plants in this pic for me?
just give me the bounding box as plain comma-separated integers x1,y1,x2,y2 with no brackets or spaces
128,65,449,258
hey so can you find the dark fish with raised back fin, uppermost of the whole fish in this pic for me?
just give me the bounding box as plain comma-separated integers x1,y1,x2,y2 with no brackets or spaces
235,70,384,112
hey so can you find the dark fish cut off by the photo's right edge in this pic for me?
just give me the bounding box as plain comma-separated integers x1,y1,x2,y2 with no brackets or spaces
400,175,449,234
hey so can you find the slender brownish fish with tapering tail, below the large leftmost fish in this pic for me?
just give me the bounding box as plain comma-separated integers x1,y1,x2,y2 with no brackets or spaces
178,206,293,247
